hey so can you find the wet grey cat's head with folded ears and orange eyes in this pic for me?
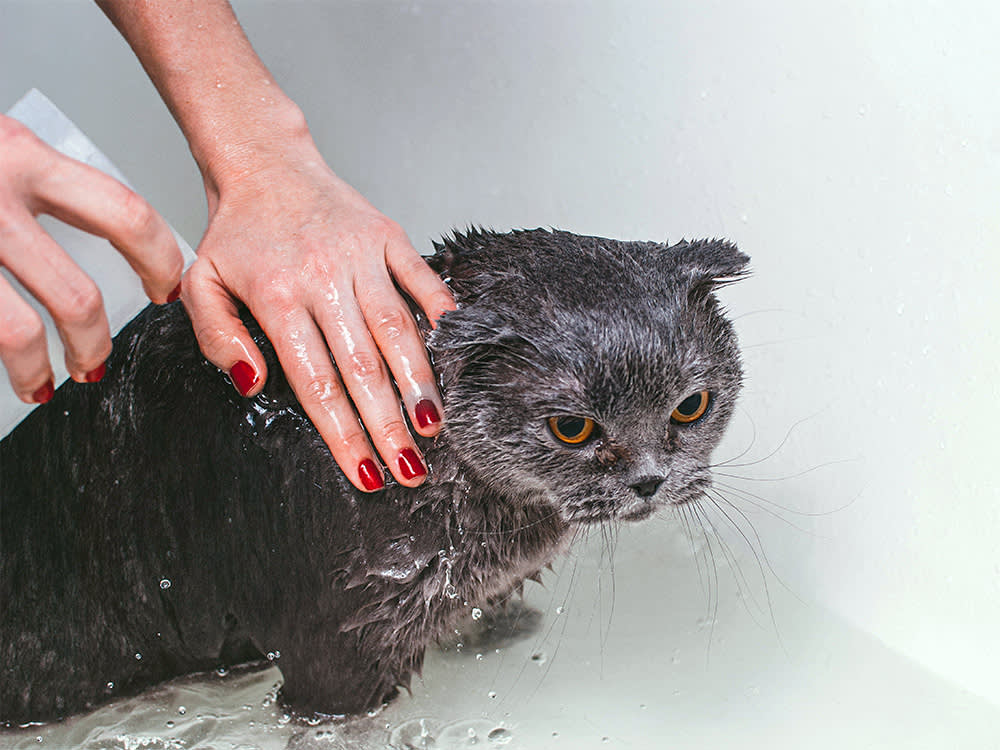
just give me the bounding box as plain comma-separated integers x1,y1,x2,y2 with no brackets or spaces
428,229,748,523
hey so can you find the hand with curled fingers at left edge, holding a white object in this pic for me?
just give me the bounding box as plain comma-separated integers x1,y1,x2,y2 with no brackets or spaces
0,115,184,403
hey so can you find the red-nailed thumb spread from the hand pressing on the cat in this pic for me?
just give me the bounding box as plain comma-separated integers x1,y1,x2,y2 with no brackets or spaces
181,258,267,396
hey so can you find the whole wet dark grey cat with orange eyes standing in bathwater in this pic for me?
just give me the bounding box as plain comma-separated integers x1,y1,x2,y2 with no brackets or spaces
0,229,748,724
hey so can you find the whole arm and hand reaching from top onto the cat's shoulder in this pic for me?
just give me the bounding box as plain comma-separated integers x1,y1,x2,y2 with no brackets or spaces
98,0,454,491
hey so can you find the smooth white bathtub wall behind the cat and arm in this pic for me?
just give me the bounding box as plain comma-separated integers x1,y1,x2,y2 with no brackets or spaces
0,0,1000,703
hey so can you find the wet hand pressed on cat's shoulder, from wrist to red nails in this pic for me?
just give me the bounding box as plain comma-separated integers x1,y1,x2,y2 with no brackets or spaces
182,139,454,491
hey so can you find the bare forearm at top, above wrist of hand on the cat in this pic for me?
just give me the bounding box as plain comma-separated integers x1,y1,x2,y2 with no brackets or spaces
97,0,311,198
